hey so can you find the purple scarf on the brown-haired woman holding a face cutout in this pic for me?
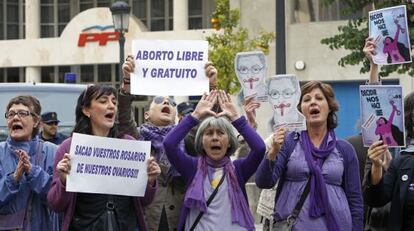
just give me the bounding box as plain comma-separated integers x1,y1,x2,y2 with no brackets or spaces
301,129,339,231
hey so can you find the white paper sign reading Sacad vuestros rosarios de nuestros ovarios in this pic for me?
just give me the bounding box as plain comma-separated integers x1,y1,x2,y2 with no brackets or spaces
66,133,151,196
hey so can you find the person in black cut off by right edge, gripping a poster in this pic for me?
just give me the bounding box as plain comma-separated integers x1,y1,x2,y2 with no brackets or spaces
364,92,414,230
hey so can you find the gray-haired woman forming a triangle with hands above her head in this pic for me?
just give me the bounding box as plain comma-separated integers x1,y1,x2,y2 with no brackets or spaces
163,91,266,231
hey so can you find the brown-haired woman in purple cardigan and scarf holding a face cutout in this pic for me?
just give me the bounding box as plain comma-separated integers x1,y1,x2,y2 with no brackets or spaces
256,81,363,231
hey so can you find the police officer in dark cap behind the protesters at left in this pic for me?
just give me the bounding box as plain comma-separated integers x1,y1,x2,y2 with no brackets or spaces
40,112,67,145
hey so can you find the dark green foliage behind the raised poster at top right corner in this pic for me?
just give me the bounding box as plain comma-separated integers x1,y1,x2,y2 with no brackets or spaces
321,0,414,77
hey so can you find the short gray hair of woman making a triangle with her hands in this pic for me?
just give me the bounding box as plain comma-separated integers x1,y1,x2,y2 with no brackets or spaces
194,116,239,156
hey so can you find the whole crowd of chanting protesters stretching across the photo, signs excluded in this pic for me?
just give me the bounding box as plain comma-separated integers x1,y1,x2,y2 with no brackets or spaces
0,36,414,231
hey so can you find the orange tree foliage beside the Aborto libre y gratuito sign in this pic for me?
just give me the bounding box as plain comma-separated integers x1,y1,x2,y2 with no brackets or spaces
206,0,275,94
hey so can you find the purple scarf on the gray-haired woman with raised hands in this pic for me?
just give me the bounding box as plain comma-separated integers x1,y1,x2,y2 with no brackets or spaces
184,156,254,230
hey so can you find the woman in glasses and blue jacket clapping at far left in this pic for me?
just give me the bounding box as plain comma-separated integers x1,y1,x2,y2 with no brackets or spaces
0,96,56,231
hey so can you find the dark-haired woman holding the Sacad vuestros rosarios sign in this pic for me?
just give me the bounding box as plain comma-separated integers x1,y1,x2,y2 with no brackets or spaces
48,85,160,231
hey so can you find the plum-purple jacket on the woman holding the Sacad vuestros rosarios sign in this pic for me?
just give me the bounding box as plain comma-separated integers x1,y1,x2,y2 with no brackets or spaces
47,136,157,231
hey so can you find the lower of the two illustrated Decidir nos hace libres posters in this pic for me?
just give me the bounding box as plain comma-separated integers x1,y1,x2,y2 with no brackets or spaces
360,86,405,147
